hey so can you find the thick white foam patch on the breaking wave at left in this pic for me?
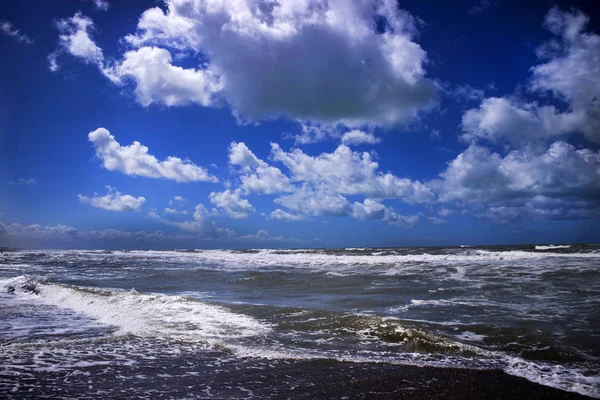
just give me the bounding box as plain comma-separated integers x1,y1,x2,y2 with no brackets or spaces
0,277,270,342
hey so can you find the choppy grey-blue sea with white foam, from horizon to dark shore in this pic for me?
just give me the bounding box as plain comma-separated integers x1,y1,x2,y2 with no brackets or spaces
0,245,600,398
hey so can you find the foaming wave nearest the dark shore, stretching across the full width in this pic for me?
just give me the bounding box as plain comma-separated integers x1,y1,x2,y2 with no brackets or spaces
0,276,600,397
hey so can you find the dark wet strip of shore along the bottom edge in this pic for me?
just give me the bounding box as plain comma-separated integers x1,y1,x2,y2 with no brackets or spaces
0,354,592,400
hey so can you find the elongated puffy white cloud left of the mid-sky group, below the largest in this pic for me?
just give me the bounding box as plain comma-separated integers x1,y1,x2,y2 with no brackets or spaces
88,128,218,182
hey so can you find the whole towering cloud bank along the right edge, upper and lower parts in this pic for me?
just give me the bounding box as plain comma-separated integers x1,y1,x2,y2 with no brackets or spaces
440,7,600,221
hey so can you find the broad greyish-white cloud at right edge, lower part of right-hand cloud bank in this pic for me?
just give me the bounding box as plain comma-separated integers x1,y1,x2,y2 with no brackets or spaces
431,141,600,206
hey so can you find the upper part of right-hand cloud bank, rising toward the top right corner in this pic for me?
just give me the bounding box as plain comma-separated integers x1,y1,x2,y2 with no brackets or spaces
462,7,600,148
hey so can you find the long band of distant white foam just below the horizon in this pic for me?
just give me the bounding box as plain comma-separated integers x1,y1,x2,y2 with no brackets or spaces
9,248,600,280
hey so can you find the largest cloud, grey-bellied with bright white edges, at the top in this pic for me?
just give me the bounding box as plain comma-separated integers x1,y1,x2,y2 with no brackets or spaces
61,0,438,127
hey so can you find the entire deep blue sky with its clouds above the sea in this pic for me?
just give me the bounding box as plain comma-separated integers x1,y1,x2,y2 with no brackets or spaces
0,0,600,249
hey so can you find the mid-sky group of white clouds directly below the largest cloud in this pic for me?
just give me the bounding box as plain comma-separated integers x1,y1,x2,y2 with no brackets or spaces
225,142,426,226
